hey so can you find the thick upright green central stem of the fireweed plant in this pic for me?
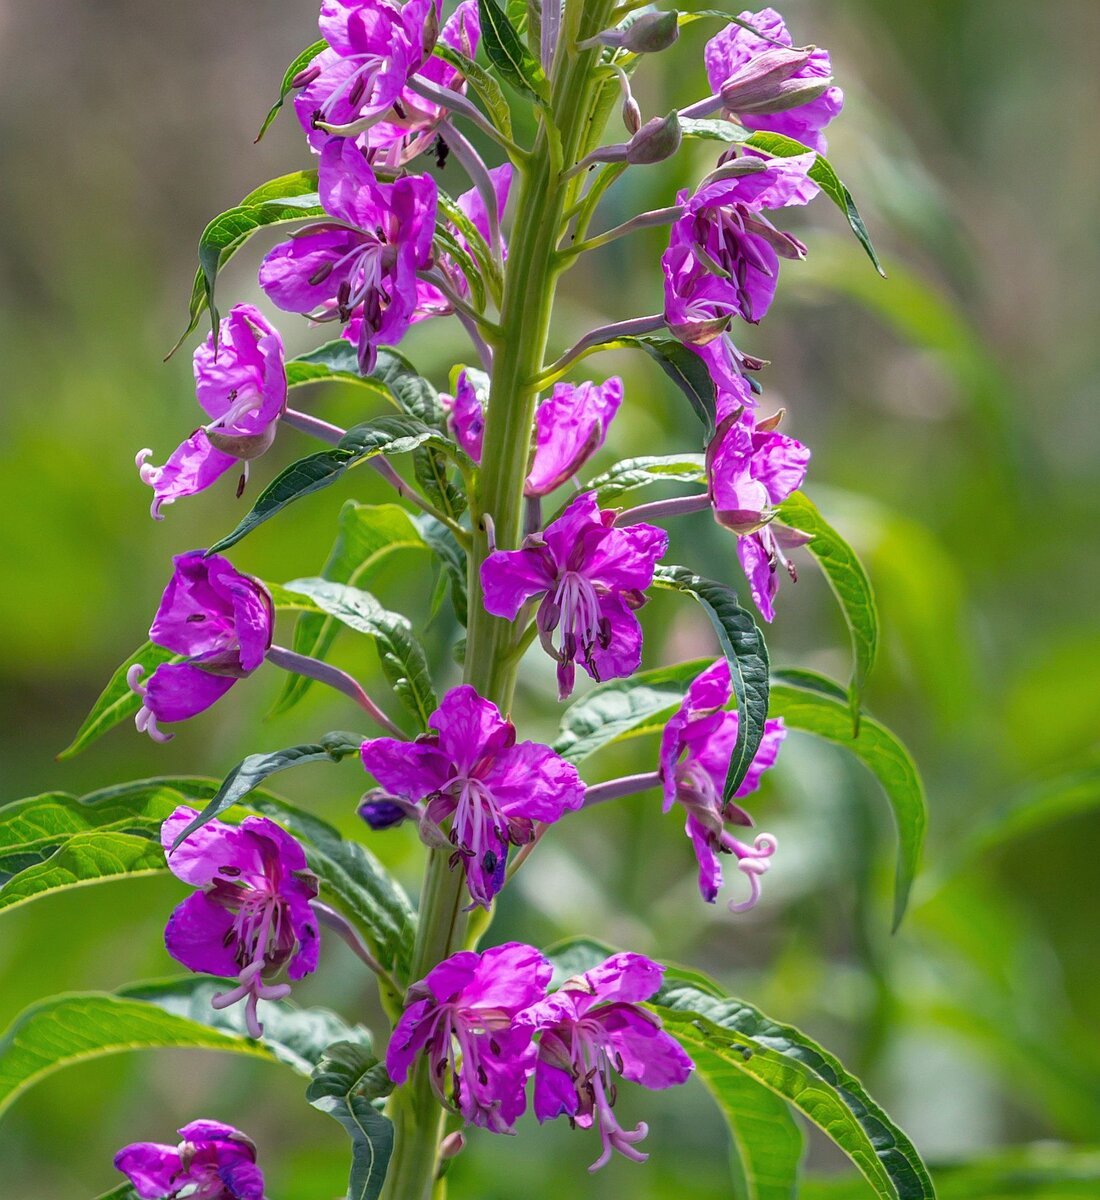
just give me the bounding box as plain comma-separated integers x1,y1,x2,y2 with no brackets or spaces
384,0,613,1200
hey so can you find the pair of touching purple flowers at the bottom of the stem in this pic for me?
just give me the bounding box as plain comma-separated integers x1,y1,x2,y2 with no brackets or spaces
386,942,692,1170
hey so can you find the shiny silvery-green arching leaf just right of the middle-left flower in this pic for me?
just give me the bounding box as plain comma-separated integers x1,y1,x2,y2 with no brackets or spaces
288,578,439,730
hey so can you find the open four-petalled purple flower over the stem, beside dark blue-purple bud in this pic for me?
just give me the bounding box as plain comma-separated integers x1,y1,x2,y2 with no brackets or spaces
362,685,584,908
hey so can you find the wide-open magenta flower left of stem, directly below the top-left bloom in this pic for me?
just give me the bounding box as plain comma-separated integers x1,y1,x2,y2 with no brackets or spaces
259,138,435,373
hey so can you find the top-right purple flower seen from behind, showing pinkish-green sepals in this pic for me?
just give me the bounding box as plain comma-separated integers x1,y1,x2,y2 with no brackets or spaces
704,8,844,154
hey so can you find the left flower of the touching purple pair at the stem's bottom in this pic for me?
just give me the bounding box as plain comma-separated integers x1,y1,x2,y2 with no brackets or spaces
386,942,552,1133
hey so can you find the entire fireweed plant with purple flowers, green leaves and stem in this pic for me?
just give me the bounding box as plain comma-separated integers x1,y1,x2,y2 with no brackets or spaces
0,0,932,1200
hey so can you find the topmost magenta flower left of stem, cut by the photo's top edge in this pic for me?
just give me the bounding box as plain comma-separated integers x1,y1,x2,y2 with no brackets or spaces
294,0,446,152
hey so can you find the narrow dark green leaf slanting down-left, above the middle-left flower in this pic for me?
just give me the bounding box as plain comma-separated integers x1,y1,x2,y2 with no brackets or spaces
208,415,451,554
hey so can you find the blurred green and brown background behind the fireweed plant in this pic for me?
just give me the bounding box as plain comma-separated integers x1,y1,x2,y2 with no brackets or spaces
0,0,1100,1200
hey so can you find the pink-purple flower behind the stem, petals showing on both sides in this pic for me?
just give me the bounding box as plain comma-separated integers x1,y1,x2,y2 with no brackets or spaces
445,371,623,496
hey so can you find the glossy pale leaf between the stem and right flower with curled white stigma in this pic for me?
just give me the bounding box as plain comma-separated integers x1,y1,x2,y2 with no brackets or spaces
554,659,711,762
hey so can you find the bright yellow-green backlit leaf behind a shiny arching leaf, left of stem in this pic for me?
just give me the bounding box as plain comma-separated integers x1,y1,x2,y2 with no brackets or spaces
274,500,429,713
